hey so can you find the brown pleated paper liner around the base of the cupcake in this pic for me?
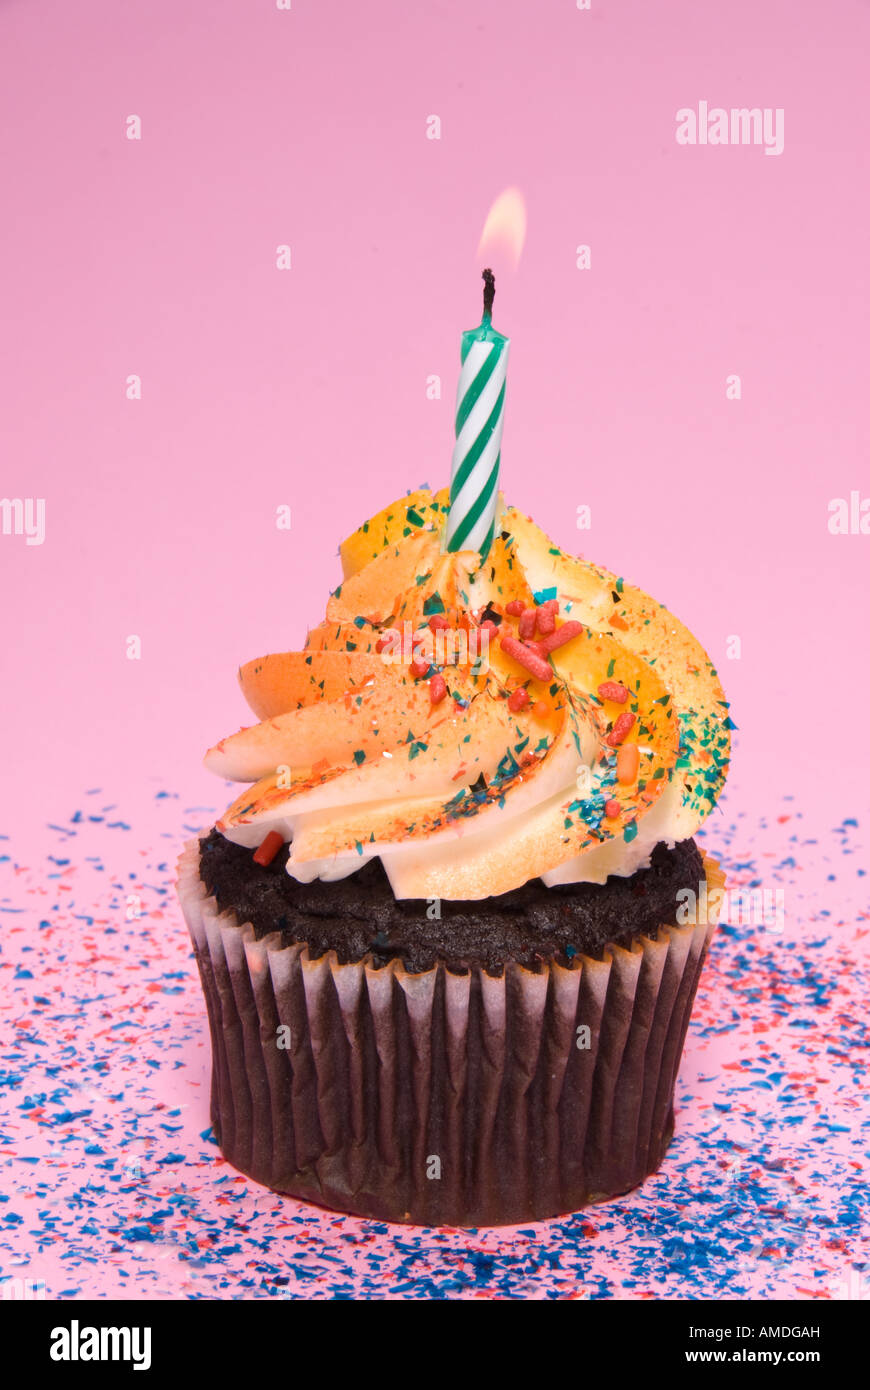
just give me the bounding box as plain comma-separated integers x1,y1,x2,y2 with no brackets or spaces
178,841,724,1226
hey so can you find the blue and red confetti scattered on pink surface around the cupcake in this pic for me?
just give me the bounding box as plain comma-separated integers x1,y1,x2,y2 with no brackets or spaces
0,790,870,1300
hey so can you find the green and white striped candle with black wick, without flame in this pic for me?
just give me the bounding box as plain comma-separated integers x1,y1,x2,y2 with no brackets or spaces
446,270,510,556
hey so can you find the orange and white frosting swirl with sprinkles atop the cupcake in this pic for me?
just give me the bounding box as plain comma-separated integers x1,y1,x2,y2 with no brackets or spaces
206,491,732,899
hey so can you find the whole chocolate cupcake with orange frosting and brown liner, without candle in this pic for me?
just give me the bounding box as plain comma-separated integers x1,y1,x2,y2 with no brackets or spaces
178,489,731,1226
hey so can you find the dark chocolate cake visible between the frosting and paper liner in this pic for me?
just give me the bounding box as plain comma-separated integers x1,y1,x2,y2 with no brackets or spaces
200,830,705,976
